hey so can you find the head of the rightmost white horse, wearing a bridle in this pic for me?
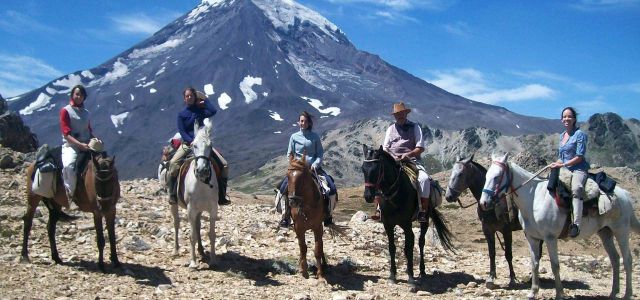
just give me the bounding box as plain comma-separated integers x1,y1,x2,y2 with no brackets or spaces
480,153,512,210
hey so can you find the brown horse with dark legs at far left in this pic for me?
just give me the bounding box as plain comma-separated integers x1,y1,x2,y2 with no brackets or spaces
21,153,120,272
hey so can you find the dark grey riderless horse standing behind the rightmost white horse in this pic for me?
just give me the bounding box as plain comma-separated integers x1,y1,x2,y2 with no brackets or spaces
445,155,518,288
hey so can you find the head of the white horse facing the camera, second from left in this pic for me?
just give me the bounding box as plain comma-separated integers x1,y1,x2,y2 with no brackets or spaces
191,118,213,184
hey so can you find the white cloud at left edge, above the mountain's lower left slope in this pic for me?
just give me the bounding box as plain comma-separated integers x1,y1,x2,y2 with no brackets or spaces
0,53,62,98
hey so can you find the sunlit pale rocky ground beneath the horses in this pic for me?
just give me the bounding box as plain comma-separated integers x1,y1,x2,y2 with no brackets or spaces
0,162,640,299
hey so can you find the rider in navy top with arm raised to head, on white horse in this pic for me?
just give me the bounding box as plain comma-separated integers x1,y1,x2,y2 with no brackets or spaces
167,87,231,205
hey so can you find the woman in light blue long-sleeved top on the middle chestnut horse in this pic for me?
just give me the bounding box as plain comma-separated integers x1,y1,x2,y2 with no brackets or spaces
280,111,337,228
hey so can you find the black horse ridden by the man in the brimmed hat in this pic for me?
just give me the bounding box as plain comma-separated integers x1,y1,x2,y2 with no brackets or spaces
362,145,453,289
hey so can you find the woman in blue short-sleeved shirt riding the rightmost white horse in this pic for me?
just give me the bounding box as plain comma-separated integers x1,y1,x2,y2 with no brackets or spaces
551,107,589,238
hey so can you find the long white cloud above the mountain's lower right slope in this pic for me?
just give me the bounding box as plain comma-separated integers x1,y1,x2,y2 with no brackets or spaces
427,69,556,104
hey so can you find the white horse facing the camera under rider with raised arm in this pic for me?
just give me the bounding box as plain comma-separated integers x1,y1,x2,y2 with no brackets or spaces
171,119,218,268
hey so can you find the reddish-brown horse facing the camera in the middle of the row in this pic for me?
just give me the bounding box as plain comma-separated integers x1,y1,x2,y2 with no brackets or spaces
287,155,327,279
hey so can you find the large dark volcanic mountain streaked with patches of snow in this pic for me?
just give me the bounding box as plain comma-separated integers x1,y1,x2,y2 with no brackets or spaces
9,0,557,178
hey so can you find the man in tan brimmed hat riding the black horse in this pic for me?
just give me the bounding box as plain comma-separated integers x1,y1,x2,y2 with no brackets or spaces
382,102,431,223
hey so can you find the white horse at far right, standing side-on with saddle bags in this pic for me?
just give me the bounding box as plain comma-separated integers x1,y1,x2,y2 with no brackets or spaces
480,154,640,299
